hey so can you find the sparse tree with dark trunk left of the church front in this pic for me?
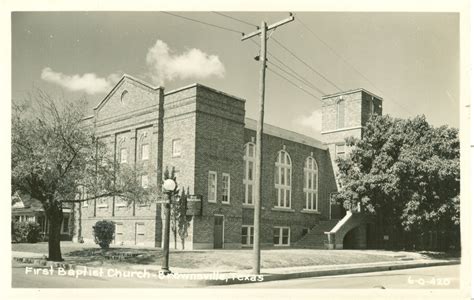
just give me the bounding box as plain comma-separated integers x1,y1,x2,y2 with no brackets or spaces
11,90,159,261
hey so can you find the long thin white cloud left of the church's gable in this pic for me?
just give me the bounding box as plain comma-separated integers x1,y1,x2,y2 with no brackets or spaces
41,67,120,95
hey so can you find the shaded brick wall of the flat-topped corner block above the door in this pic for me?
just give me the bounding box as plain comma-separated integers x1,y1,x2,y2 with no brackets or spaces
194,86,245,248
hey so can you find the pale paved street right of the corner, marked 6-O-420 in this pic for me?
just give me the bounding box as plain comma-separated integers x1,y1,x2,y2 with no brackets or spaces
228,265,460,289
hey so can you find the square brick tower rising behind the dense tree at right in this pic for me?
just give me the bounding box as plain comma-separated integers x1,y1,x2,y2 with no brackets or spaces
321,89,382,170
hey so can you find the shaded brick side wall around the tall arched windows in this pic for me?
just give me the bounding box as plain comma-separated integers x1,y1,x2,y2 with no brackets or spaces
242,129,337,246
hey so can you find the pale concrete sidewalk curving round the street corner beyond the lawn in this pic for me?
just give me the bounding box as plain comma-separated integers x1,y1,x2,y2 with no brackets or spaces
12,251,460,286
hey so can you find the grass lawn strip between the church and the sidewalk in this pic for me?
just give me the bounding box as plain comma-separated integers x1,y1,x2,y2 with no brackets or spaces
12,242,410,271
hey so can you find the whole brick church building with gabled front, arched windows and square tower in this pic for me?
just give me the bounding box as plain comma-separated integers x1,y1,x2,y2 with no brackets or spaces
74,75,382,249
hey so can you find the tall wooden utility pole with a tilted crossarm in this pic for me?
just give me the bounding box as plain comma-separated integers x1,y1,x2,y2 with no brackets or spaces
241,13,295,275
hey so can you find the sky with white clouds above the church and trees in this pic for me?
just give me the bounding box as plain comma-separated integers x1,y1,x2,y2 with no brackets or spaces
12,12,460,139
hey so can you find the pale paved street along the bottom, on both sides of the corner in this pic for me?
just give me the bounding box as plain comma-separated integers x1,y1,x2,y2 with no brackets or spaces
12,265,460,289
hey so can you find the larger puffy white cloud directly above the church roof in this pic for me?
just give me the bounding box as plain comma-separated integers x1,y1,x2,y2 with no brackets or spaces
146,40,225,85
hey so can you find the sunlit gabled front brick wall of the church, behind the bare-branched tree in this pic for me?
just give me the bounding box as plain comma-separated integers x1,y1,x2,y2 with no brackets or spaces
80,77,163,246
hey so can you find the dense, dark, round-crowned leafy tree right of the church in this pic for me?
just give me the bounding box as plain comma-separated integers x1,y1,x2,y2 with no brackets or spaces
336,116,460,247
